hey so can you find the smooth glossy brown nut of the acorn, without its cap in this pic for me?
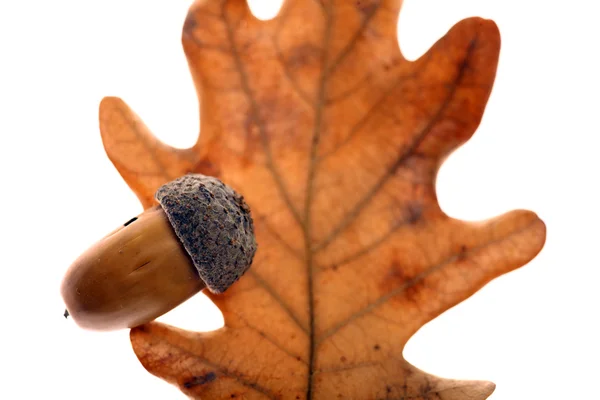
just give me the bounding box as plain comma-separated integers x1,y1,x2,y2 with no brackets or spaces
61,206,205,330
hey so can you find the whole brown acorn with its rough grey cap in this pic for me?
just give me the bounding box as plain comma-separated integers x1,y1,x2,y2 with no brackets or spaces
61,174,256,331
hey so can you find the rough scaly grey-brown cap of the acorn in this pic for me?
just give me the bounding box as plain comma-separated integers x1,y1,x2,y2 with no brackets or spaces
154,174,256,293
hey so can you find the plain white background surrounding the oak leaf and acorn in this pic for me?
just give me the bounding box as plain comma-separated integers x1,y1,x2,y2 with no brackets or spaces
0,0,600,400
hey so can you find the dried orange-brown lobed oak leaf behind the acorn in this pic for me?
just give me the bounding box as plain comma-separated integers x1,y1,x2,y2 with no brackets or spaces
100,0,545,400
